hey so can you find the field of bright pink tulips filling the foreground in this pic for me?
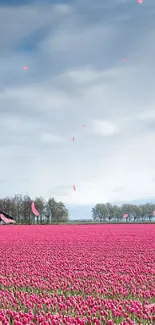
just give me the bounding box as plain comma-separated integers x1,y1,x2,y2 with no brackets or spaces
0,224,155,325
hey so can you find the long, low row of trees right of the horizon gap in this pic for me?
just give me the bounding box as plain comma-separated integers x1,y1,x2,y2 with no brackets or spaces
92,202,155,222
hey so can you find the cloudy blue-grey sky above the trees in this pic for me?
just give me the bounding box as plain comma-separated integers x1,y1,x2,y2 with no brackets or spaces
0,0,155,219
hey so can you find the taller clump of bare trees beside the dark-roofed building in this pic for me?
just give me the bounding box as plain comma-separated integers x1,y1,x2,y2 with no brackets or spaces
0,194,69,224
